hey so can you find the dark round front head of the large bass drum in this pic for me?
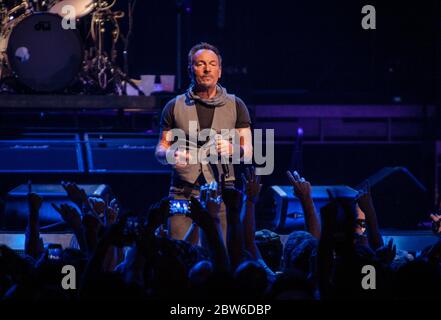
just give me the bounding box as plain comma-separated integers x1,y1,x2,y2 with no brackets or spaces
7,13,83,92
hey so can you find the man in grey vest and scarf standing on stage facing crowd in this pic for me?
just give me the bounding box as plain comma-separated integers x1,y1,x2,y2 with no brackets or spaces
156,43,253,239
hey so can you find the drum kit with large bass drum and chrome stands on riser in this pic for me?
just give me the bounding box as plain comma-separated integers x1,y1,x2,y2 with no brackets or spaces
0,0,142,95
